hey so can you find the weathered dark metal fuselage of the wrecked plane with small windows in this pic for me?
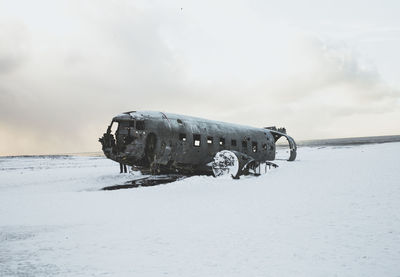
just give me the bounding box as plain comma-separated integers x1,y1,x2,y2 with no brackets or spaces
99,111,296,175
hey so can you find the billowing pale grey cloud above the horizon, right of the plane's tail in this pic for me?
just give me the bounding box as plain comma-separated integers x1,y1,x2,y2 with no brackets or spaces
222,36,400,138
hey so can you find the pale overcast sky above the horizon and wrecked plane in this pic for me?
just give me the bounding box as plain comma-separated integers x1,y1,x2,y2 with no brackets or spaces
0,0,400,155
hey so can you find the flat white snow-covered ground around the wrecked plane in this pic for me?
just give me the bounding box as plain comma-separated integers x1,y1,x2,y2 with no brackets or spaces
0,143,400,277
